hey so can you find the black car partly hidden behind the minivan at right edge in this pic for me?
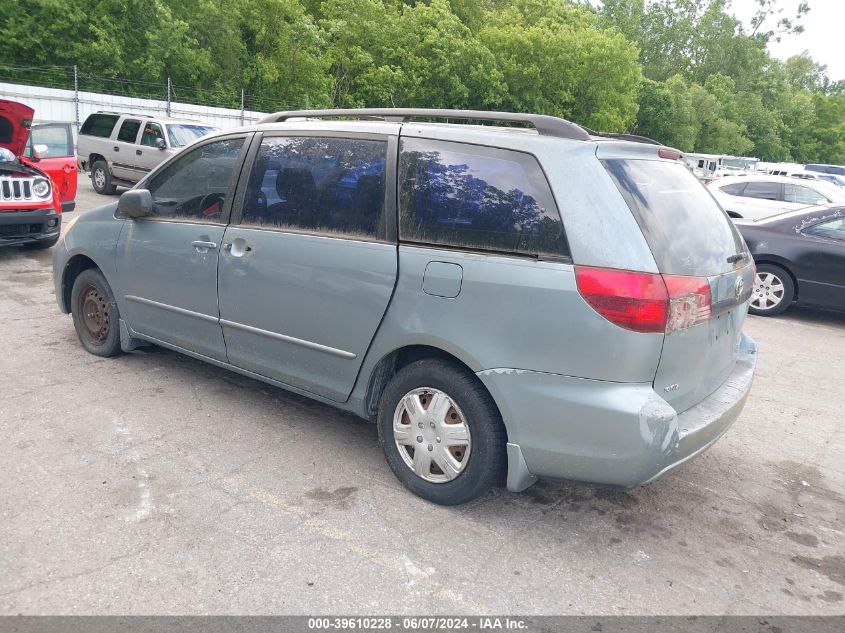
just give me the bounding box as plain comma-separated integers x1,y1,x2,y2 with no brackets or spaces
736,206,845,316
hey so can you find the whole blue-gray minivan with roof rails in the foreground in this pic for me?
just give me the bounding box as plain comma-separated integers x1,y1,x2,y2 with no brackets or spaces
53,109,756,504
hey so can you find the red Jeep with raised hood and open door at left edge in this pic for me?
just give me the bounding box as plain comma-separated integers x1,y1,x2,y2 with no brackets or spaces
0,99,77,248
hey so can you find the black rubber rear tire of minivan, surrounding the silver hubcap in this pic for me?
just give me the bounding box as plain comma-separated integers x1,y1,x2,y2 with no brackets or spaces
378,359,507,505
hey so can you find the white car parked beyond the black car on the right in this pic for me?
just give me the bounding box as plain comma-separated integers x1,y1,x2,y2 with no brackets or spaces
707,176,845,220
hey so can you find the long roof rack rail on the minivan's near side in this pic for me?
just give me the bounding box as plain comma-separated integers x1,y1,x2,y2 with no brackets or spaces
258,108,590,141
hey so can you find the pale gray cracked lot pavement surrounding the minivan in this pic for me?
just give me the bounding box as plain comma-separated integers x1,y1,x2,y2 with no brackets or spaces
0,178,845,614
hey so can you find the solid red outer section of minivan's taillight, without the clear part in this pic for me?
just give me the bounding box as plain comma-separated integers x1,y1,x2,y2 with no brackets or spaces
575,266,669,332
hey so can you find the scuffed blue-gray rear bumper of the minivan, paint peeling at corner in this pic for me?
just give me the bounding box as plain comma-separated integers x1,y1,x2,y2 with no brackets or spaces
478,334,757,490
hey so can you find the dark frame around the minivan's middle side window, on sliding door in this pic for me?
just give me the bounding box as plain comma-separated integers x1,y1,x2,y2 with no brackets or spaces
229,130,399,244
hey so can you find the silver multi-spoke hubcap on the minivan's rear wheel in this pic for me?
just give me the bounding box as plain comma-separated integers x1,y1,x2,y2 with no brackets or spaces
393,387,472,483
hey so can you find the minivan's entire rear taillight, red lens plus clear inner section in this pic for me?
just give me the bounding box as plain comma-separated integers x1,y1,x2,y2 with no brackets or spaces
575,266,712,334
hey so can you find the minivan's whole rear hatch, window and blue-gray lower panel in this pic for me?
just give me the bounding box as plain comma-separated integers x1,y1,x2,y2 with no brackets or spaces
602,158,754,412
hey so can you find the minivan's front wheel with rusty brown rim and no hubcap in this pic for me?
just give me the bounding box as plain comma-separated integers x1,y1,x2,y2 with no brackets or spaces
70,268,121,357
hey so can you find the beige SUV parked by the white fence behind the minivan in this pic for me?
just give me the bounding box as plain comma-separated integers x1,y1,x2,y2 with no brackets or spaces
77,111,217,195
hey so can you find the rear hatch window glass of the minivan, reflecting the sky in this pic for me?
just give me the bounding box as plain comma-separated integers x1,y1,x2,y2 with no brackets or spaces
602,159,745,276
